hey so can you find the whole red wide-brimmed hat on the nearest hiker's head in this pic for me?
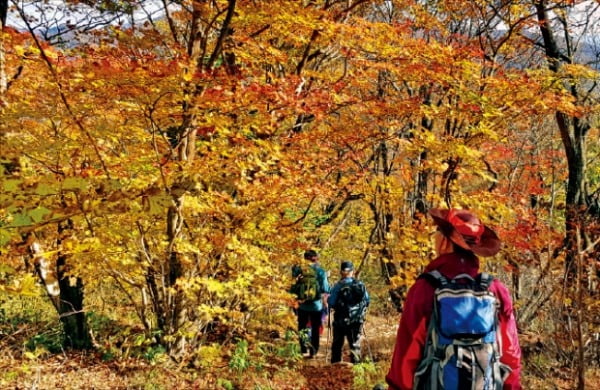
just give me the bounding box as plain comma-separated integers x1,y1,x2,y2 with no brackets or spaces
429,208,501,257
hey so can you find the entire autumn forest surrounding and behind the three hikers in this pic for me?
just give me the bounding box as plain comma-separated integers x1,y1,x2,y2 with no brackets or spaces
0,0,600,389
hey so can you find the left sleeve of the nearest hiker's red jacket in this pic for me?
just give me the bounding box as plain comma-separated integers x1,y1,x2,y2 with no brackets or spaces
385,279,434,390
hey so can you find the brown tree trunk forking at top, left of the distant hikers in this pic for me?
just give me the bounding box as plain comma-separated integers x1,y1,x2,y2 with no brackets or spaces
139,0,236,358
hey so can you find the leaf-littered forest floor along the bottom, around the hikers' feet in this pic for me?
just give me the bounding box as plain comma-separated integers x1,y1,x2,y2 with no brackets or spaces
0,316,600,390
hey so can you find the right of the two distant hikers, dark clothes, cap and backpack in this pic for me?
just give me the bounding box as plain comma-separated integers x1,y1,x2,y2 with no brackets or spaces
328,261,369,363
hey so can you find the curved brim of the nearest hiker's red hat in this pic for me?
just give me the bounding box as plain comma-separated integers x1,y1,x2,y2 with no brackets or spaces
429,208,502,257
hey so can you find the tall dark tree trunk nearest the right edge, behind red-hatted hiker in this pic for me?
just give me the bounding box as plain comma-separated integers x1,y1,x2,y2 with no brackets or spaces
534,0,600,390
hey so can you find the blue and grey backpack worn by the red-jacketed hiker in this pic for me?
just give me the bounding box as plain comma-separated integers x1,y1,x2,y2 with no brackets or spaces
414,271,511,390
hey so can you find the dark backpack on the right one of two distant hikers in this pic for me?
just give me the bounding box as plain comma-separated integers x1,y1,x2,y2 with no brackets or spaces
334,279,367,325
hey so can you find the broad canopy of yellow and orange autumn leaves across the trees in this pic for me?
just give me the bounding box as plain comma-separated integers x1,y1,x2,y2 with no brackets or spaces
0,0,597,355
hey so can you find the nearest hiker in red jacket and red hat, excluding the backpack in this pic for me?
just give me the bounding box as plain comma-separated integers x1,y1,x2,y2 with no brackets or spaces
386,209,521,390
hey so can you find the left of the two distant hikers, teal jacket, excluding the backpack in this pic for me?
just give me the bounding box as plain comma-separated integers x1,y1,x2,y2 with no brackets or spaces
292,249,329,358
